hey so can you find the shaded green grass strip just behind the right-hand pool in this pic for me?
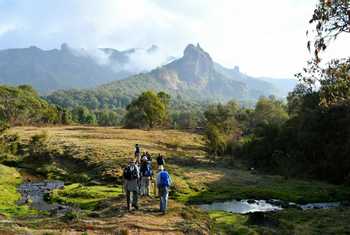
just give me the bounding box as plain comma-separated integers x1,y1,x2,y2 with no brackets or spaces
175,169,350,204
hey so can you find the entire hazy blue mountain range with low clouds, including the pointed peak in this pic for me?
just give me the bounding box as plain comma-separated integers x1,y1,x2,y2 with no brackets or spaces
0,44,296,101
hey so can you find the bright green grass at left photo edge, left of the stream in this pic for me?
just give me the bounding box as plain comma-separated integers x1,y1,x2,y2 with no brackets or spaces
0,164,37,217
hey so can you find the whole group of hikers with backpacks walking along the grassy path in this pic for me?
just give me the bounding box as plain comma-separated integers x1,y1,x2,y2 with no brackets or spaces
123,144,171,214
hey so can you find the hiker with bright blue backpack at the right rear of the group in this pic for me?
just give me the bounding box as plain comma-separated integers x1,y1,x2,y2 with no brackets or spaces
157,168,171,214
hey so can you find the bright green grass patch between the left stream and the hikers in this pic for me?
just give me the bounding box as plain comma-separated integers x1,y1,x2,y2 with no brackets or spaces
50,184,122,210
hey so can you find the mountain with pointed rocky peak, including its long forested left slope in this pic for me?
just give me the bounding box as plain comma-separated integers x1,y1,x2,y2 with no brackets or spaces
48,44,298,109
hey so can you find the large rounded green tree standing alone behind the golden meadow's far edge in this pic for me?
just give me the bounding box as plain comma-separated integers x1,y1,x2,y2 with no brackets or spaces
125,91,168,128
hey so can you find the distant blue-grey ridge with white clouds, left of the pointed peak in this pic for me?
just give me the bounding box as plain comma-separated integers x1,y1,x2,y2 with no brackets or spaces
0,44,167,94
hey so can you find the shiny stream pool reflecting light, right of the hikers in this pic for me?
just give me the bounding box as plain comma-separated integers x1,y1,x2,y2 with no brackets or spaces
199,199,341,214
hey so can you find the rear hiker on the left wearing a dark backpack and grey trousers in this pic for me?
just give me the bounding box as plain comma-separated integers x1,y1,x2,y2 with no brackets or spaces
123,159,140,211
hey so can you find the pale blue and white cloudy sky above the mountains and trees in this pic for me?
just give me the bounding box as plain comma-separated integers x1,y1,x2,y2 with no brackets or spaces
0,0,350,78
